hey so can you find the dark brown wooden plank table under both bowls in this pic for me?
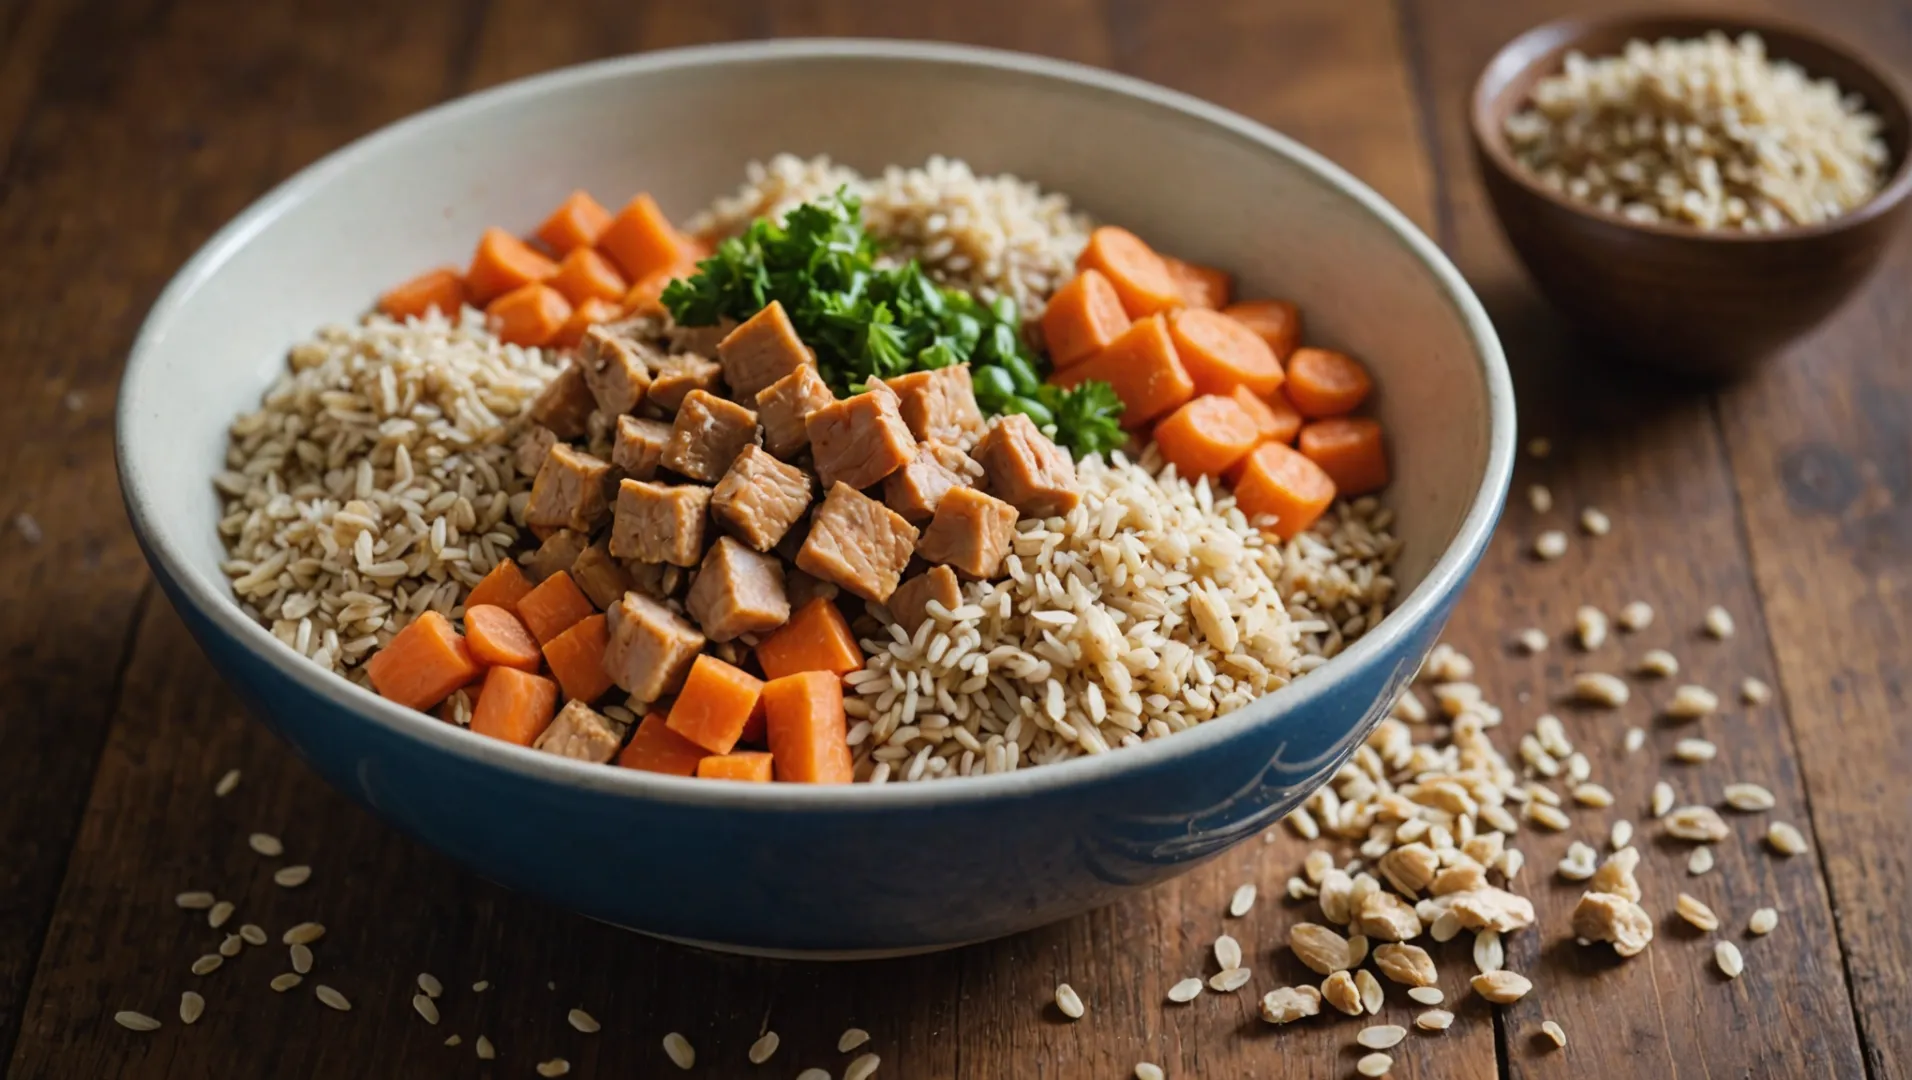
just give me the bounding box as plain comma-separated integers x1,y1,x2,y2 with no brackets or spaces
0,0,1912,1080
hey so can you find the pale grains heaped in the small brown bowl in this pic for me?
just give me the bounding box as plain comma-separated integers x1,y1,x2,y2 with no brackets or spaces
1505,32,1887,231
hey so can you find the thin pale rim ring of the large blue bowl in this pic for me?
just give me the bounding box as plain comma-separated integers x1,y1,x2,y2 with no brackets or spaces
115,38,1516,812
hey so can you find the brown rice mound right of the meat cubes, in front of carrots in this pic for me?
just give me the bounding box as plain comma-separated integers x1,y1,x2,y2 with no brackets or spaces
847,447,1398,782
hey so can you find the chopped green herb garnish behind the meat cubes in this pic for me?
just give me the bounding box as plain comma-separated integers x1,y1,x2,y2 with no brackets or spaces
663,191,1126,457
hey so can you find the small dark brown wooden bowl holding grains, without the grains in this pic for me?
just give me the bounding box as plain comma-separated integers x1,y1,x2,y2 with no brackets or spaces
1470,13,1912,377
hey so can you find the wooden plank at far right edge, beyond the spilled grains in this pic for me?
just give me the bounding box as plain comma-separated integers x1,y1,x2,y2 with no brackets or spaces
1719,0,1912,1080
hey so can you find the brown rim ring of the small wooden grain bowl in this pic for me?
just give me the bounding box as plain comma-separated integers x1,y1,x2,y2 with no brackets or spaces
1467,8,1912,245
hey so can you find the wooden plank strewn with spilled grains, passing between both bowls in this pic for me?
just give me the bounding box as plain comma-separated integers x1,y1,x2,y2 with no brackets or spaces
1401,0,1860,1076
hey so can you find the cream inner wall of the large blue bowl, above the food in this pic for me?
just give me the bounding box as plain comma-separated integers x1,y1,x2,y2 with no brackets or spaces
120,42,1512,787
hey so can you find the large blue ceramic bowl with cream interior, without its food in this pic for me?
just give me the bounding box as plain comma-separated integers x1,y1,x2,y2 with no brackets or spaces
119,40,1514,956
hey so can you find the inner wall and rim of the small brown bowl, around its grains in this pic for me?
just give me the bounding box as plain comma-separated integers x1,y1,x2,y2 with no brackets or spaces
1470,11,1912,243
